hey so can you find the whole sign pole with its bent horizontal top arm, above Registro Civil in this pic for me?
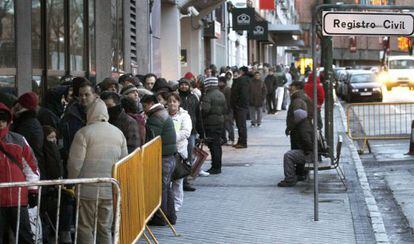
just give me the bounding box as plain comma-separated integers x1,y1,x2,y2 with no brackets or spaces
311,4,414,221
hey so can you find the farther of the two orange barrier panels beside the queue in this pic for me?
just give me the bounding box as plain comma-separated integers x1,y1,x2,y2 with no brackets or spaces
142,136,162,222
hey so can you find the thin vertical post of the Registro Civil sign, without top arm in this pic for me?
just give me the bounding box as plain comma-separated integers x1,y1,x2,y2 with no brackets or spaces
311,4,319,221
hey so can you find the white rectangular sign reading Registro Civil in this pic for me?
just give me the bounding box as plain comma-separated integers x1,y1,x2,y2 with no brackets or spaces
322,11,414,36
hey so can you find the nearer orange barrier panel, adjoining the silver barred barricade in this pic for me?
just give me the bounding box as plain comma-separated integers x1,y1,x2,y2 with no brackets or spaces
113,148,148,244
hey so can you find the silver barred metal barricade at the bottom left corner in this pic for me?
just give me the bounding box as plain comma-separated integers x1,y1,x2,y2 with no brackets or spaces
0,178,121,244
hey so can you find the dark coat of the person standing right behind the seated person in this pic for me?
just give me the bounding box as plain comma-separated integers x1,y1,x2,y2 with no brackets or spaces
286,90,313,131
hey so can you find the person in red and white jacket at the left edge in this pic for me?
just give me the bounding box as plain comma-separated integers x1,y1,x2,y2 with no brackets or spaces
0,103,39,243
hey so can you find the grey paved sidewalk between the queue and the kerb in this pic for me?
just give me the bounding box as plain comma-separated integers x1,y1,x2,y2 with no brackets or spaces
148,111,356,243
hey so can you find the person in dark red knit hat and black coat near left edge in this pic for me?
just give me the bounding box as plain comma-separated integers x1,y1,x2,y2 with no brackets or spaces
11,92,44,166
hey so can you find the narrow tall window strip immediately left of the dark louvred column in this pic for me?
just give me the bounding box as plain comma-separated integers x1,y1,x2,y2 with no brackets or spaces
111,0,124,72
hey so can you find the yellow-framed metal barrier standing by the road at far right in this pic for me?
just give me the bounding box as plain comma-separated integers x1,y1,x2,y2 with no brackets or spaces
347,103,414,140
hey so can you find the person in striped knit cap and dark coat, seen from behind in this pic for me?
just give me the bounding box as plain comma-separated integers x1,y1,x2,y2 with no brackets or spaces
200,77,227,174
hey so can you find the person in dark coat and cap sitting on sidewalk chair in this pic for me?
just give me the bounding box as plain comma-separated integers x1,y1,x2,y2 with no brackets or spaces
277,109,313,187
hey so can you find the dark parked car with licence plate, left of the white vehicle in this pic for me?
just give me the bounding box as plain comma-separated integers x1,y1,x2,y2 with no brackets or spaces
342,70,382,102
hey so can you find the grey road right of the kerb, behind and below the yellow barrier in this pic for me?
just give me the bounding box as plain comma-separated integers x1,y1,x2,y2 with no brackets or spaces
344,87,414,243
